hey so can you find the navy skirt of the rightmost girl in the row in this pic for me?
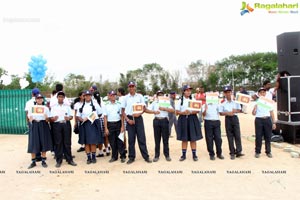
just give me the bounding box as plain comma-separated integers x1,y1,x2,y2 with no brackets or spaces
177,114,203,141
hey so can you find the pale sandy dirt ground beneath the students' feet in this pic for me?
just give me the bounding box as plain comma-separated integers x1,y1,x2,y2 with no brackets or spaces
0,104,300,200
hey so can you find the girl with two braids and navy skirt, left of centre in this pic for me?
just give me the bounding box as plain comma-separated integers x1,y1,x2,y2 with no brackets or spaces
76,91,103,164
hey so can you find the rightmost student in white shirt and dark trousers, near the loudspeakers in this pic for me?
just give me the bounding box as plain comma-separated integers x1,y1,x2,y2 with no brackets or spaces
252,87,276,158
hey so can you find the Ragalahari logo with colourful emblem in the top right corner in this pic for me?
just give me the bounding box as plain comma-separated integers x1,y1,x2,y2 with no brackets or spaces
241,1,299,16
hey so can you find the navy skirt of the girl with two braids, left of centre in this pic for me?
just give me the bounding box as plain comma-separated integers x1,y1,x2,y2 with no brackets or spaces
79,119,104,144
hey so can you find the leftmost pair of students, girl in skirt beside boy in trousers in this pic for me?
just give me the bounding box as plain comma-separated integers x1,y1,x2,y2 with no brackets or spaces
25,84,77,169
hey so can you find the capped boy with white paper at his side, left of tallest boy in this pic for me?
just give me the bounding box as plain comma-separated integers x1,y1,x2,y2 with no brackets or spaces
103,90,126,163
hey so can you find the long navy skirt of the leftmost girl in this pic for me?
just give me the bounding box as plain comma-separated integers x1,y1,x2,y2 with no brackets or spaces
27,120,53,153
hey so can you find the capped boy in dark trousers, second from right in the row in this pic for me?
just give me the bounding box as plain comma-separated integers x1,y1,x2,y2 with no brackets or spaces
219,86,244,160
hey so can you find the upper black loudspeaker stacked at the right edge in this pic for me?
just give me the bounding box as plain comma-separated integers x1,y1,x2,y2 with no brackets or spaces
277,32,300,76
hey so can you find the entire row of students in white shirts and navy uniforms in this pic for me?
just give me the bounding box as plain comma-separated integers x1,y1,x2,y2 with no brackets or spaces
25,81,276,168
